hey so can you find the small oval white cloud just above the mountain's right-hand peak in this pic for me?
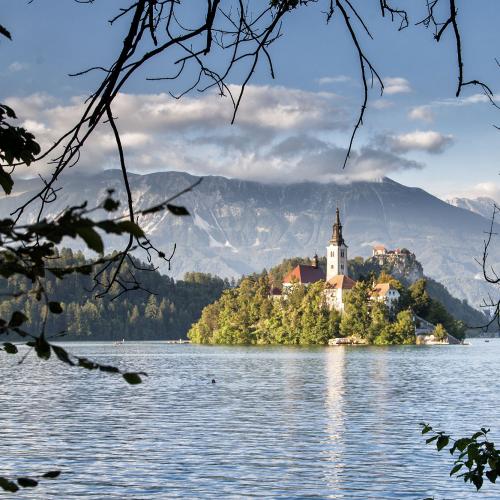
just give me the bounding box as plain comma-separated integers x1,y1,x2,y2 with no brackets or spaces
376,130,453,154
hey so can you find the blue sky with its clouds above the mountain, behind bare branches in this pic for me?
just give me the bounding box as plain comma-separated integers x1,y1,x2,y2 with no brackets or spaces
0,0,500,201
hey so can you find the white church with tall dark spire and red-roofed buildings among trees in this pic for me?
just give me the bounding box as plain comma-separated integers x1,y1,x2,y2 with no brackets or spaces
278,208,399,312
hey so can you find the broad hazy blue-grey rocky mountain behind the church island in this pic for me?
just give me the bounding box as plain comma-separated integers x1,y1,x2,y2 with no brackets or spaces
0,170,500,306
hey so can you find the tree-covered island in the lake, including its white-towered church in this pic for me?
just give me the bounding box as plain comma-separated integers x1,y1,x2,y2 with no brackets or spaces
188,208,480,345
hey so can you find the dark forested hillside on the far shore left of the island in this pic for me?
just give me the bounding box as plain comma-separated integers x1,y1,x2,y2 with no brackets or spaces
0,249,230,340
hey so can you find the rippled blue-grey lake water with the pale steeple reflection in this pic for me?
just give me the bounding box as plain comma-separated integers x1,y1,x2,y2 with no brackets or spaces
0,340,500,500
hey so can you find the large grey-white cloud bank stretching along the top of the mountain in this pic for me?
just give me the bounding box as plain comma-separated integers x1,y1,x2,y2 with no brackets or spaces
6,86,422,183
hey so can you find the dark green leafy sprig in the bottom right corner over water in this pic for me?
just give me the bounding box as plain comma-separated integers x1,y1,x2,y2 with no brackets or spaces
420,423,500,490
